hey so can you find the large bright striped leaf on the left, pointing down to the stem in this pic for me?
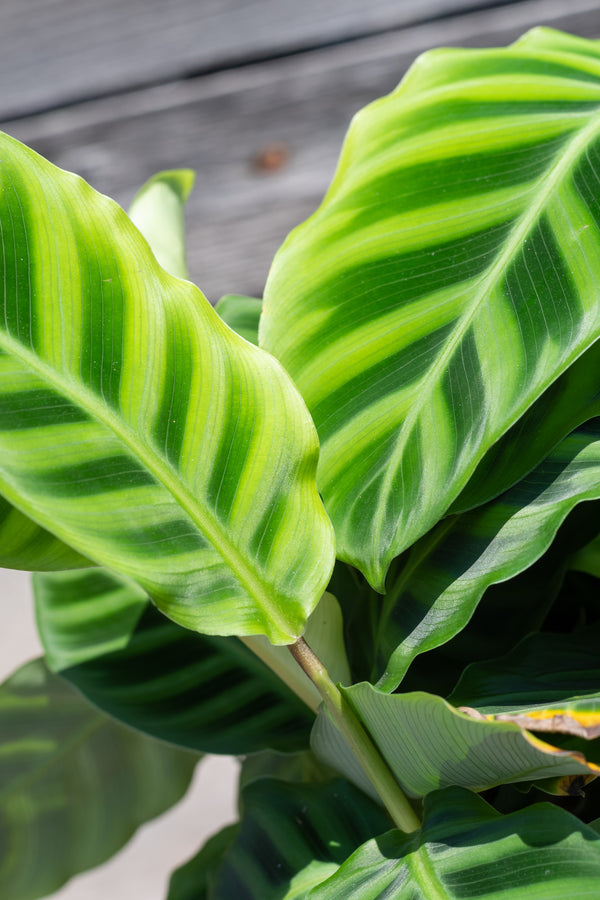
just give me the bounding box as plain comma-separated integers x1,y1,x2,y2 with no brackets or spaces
0,130,334,644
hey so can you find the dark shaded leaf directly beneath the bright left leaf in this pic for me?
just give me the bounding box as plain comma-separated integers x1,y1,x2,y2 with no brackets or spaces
34,569,313,754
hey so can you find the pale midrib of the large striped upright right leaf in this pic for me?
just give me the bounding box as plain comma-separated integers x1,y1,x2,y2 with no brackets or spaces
372,110,600,548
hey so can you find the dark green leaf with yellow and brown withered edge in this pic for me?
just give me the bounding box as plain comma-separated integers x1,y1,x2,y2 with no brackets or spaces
448,623,600,739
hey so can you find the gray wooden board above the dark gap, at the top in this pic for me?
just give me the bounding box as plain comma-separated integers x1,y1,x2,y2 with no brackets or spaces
0,0,506,118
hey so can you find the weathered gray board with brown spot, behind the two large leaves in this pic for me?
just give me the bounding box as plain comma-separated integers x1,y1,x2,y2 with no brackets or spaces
4,0,600,302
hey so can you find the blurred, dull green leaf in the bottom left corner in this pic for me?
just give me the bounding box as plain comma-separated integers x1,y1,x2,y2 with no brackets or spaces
0,660,197,900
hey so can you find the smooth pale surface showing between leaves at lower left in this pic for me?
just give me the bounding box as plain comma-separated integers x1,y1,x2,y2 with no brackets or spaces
0,569,238,900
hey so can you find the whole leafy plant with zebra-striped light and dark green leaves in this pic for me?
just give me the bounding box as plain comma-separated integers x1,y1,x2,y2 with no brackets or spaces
0,30,600,900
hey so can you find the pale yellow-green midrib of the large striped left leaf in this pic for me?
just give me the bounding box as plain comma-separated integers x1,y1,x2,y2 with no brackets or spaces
0,331,289,635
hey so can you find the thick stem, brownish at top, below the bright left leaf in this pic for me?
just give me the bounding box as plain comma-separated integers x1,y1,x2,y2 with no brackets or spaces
288,637,421,834
